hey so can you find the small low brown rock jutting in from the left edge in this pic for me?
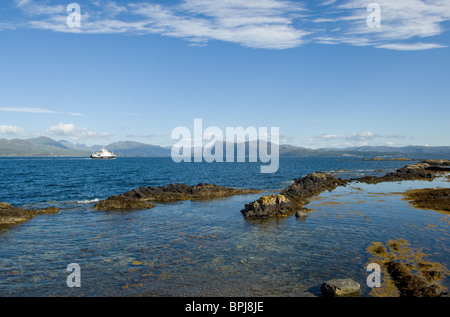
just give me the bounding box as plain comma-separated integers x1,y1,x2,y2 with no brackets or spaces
0,203,59,229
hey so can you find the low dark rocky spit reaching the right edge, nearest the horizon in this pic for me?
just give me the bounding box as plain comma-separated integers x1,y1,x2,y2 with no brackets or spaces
351,160,450,184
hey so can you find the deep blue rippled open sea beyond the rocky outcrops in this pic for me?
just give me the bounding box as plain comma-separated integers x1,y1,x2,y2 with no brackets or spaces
0,158,410,205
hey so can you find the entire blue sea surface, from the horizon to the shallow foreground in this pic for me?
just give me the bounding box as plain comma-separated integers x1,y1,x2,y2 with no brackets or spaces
0,158,450,296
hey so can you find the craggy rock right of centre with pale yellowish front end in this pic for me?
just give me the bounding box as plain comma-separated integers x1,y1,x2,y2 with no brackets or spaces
241,172,347,218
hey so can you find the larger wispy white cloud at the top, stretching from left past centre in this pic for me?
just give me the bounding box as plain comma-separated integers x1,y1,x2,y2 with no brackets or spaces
10,0,308,49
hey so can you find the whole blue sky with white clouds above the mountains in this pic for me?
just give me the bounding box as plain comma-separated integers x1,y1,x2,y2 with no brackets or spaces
0,0,450,148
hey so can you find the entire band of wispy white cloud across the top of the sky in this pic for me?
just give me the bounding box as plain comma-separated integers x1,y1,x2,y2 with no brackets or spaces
6,0,450,51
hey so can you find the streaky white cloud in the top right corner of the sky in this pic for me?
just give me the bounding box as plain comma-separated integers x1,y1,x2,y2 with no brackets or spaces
316,0,450,50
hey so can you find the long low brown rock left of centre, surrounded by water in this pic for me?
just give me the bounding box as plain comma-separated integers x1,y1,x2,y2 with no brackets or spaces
94,183,261,210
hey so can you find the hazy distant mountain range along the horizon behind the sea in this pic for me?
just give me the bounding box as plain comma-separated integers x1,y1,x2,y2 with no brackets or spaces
0,137,450,159
